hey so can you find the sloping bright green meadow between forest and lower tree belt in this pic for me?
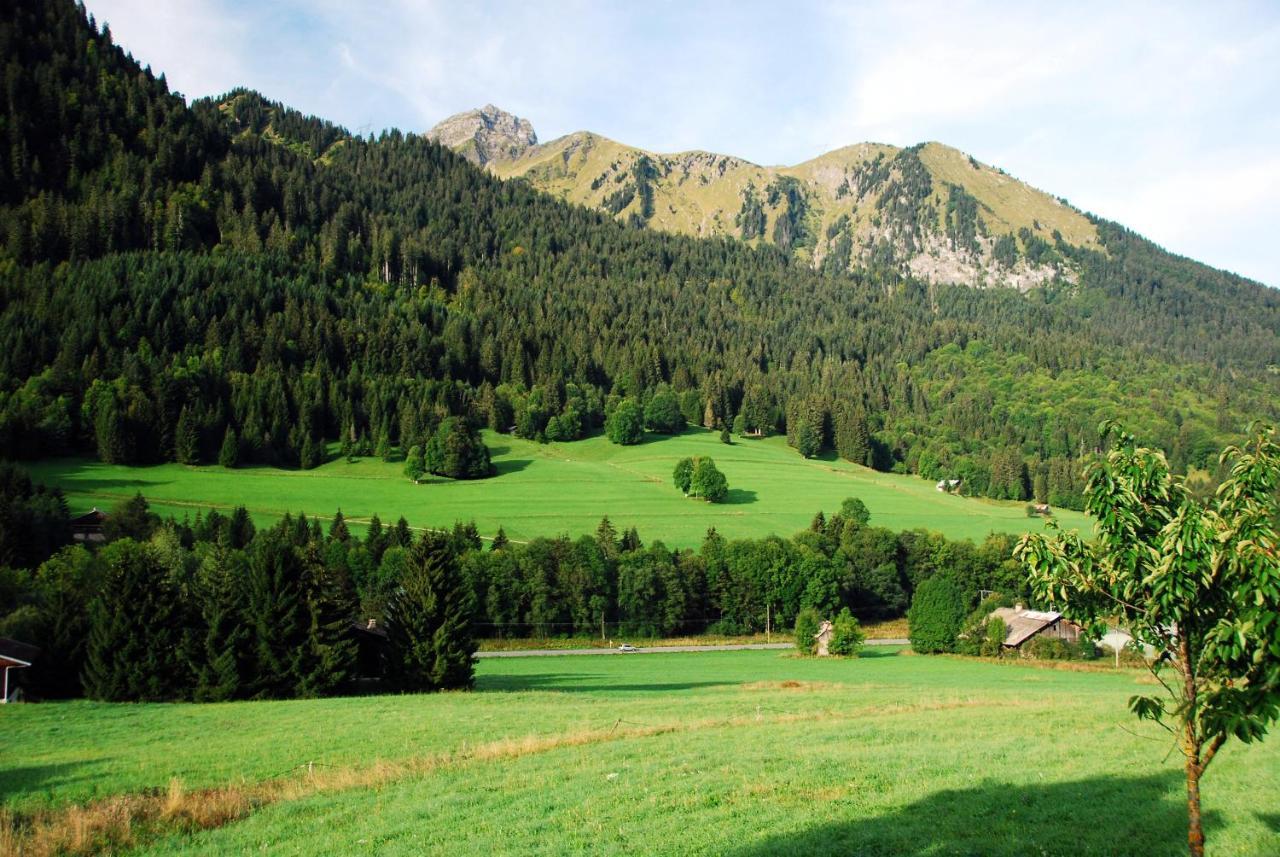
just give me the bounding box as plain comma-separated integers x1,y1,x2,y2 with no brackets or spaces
31,430,1089,547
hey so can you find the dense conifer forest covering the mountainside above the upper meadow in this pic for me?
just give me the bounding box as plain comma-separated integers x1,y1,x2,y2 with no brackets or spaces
0,0,1280,508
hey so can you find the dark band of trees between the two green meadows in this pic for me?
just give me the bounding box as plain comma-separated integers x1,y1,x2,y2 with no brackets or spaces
0,478,1025,701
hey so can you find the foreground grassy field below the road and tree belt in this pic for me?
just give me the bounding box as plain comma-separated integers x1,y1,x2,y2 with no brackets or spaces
0,649,1280,857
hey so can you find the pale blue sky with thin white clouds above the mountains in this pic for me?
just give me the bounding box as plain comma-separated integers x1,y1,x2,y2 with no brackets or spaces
86,0,1280,287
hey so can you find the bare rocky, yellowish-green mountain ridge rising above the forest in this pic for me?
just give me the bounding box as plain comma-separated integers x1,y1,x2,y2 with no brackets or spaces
440,105,1131,290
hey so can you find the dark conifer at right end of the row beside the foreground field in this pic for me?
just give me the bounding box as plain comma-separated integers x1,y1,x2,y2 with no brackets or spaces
387,533,475,691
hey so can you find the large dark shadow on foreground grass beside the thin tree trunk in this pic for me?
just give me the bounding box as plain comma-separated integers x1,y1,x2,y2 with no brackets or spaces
724,760,1221,857
